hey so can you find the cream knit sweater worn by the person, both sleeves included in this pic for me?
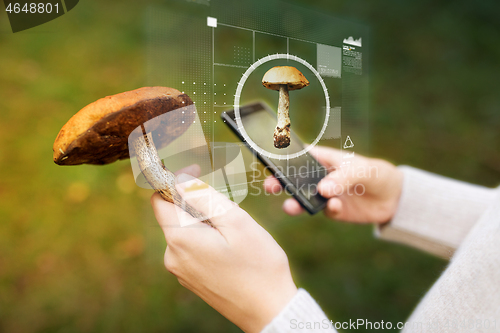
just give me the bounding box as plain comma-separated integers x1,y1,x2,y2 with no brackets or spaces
262,166,500,333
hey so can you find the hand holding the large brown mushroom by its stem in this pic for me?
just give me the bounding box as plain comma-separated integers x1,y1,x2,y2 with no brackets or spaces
151,174,297,332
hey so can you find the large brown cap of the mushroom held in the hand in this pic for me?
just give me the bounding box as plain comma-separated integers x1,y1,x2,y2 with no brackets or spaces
53,87,194,165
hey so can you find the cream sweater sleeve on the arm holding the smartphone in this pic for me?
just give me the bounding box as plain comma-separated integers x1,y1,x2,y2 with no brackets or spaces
376,166,496,259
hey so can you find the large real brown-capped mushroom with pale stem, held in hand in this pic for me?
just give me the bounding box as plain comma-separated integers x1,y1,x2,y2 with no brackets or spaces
53,87,213,226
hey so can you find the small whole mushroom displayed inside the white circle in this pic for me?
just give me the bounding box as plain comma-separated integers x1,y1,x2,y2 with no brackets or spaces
262,66,309,149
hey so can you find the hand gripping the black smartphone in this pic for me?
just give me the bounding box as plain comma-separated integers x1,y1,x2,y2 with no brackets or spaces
264,147,403,223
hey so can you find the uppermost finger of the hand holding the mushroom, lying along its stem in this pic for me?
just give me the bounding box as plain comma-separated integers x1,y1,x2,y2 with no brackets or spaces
176,174,242,227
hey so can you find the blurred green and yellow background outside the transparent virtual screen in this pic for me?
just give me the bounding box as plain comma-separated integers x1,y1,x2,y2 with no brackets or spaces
0,0,500,332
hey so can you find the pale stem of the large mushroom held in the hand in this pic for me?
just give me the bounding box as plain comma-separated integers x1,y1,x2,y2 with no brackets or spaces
134,126,215,228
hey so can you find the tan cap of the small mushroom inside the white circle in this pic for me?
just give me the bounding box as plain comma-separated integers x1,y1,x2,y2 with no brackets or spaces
262,66,309,90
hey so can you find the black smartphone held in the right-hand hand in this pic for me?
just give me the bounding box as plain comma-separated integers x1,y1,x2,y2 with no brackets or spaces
221,102,328,215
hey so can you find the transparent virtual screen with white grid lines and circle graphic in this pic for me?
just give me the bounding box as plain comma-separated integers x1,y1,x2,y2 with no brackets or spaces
145,0,369,197
